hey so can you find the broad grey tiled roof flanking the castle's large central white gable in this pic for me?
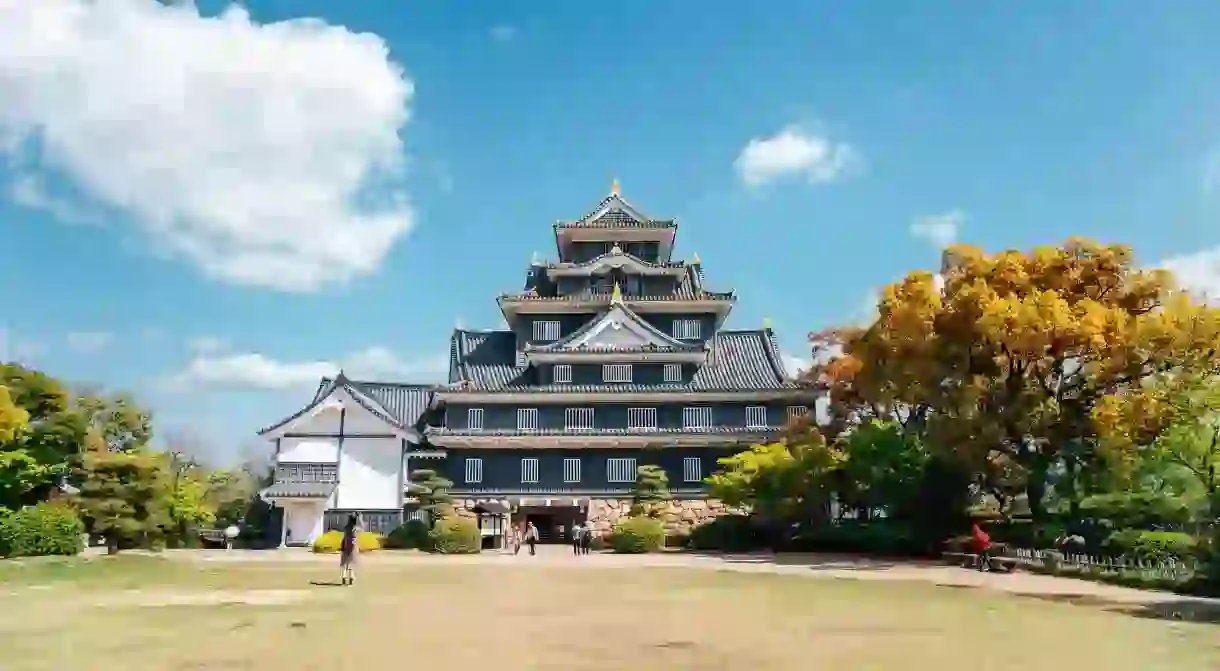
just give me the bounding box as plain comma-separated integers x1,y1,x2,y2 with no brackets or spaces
450,329,799,393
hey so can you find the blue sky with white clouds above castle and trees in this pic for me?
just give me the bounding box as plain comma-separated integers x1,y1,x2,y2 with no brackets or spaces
0,0,1220,456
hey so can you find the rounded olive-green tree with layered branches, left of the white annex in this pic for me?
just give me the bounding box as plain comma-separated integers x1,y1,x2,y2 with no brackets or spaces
77,439,172,554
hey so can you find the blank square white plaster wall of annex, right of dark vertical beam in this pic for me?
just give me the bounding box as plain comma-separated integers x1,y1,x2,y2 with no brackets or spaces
336,438,403,510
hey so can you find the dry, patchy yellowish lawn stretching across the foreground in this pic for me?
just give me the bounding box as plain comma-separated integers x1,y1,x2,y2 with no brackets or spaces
0,556,1220,671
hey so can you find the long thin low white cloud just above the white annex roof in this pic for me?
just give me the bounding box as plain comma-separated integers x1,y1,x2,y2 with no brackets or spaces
161,345,449,392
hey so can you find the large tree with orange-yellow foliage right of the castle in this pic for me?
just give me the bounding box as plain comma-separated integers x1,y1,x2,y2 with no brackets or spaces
830,239,1220,517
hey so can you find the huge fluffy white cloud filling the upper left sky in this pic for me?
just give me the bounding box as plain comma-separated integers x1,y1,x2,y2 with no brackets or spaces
0,0,414,290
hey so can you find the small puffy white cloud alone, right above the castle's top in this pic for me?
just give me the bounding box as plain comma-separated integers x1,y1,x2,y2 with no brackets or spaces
733,126,860,187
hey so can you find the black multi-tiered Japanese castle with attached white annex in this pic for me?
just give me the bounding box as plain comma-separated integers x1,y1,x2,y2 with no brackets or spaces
260,183,816,544
